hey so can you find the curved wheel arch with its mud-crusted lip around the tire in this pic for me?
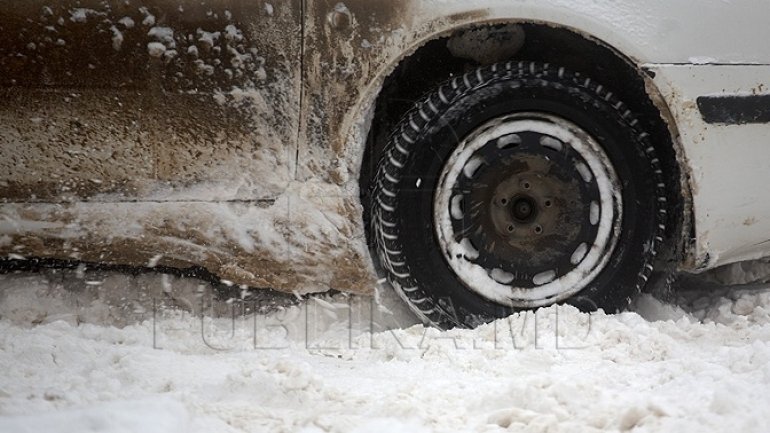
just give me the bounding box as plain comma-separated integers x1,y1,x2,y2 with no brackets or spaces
352,20,694,274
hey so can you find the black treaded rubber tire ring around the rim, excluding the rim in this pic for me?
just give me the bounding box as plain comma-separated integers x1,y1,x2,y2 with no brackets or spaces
370,62,672,328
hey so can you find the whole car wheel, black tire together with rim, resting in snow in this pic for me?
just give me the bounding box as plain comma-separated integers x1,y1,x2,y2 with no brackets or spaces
370,62,671,328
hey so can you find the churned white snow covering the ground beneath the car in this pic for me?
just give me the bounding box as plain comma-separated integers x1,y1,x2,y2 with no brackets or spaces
0,269,770,433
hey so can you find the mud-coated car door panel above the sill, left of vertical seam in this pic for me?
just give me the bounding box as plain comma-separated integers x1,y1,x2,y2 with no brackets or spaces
0,0,301,203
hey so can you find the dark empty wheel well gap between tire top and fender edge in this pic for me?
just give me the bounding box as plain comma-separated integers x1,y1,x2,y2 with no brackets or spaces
359,23,684,268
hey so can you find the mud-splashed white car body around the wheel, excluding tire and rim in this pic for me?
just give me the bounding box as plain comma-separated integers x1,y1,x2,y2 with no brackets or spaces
0,0,770,293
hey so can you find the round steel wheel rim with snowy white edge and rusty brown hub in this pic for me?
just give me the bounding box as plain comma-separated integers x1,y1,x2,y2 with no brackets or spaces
433,113,622,308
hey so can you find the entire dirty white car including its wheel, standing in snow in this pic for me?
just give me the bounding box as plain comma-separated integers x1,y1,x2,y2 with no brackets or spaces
0,0,770,328
